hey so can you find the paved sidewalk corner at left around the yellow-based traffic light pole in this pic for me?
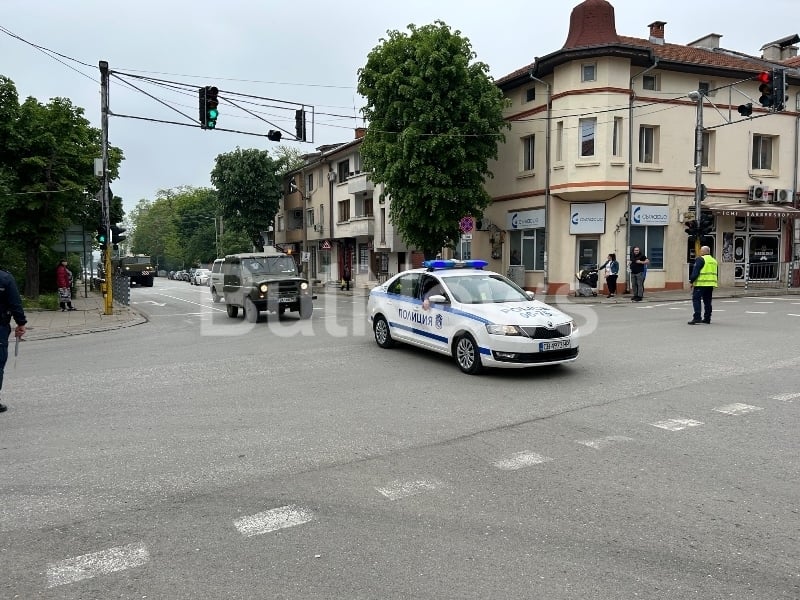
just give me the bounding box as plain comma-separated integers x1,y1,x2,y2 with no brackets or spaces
23,285,147,341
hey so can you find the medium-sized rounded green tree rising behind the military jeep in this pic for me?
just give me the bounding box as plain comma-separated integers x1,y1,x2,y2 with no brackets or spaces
211,148,284,247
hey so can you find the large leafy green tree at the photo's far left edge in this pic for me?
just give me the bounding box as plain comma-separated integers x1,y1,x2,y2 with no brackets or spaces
0,78,122,299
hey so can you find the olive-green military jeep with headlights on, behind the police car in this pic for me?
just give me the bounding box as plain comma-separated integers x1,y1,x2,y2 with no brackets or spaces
222,246,313,323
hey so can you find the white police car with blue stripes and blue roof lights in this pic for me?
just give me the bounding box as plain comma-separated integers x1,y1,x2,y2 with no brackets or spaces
367,260,578,374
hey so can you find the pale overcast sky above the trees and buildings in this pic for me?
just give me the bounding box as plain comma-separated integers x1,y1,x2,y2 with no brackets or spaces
0,0,800,216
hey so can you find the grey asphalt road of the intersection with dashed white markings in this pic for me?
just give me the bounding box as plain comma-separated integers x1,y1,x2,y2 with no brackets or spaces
0,281,800,600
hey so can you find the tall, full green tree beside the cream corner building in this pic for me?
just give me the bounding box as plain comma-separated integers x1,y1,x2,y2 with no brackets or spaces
358,21,508,256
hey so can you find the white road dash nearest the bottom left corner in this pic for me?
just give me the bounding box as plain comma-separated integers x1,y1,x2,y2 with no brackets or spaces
47,543,150,587
